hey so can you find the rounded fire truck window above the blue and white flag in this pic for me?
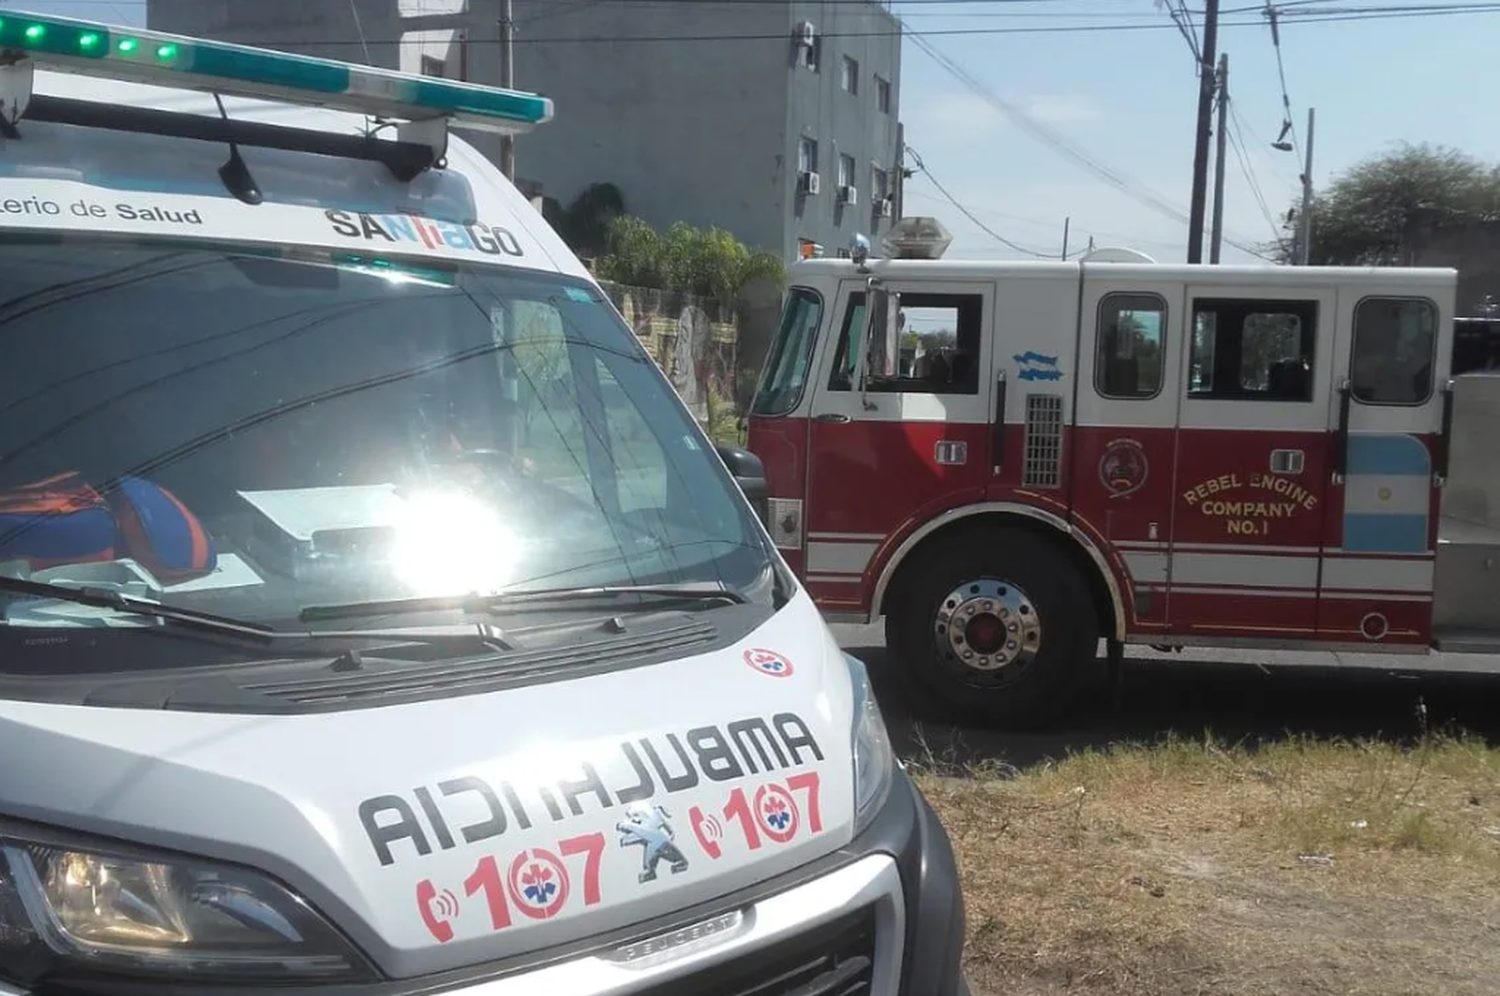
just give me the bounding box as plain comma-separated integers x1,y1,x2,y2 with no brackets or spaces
1349,297,1437,405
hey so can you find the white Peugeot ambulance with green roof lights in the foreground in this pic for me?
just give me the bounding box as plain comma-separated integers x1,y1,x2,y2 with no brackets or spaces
0,11,966,996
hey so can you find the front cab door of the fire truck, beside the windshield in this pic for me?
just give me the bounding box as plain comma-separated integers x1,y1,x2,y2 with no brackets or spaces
806,281,995,611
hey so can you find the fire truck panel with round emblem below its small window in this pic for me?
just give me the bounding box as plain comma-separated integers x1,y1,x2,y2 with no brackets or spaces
1073,277,1185,633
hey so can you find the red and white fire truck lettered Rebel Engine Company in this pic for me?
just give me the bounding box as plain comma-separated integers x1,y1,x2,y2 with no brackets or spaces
747,218,1500,728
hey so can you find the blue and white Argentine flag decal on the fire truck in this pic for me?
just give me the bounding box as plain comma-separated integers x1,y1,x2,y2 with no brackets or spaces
1344,434,1433,554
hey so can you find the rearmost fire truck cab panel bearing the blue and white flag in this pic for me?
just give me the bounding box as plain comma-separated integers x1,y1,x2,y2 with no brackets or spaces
1319,292,1451,644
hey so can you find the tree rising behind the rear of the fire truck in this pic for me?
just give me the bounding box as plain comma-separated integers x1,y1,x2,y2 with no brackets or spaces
1271,144,1500,266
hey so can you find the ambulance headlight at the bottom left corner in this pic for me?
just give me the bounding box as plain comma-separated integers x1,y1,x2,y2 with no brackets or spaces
0,833,375,989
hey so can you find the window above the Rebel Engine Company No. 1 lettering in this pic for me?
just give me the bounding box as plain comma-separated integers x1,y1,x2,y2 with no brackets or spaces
1188,299,1317,402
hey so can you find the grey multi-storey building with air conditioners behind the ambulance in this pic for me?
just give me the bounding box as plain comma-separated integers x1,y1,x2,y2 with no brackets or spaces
147,0,902,260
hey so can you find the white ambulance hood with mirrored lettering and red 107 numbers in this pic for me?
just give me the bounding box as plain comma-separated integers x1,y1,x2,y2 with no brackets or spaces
0,593,855,977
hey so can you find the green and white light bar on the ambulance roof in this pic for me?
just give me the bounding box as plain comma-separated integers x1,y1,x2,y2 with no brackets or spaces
0,11,552,136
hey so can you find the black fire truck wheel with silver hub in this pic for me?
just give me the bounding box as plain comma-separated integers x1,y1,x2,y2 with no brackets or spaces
885,527,1100,729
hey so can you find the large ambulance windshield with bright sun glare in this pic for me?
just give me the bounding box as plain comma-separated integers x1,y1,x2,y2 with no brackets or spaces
0,237,768,629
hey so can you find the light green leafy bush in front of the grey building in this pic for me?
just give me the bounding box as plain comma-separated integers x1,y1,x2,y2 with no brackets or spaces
594,215,786,305
